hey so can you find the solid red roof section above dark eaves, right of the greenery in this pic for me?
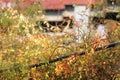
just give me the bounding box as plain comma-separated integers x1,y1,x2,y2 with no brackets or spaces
41,0,94,10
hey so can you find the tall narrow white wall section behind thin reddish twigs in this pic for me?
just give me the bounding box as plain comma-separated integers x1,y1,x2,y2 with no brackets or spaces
74,5,90,43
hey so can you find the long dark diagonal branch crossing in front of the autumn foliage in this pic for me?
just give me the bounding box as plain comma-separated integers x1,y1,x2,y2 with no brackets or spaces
0,41,120,73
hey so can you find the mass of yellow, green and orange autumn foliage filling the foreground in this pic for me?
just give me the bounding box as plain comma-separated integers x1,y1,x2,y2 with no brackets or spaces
0,4,120,80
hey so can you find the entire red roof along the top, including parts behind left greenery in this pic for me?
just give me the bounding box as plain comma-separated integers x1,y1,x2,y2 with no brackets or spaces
2,0,95,10
